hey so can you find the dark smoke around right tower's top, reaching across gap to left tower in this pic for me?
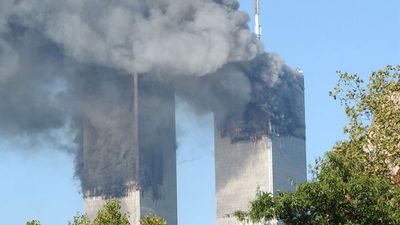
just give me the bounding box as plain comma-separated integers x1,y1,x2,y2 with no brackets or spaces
176,53,305,141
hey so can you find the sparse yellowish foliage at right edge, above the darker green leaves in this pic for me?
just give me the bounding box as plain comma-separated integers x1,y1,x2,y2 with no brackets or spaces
331,66,400,184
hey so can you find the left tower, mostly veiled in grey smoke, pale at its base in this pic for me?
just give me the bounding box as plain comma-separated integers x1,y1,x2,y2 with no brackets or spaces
78,74,177,225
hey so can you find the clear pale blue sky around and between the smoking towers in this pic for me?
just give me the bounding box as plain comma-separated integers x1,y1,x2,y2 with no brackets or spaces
0,0,400,225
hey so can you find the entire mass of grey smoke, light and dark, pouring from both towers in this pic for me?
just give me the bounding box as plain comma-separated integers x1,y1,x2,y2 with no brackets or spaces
0,0,303,195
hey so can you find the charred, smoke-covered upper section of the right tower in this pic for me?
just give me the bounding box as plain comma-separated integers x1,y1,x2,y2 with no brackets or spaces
217,54,305,143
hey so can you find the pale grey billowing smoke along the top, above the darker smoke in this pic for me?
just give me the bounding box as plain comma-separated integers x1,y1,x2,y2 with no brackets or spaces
4,0,260,76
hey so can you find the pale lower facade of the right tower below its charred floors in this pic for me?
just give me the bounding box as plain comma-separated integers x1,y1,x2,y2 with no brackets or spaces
215,133,306,225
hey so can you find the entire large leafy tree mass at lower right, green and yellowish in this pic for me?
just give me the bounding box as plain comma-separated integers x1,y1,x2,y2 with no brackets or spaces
233,66,400,225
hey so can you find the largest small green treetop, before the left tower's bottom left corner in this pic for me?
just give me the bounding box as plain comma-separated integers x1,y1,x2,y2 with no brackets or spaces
92,199,129,225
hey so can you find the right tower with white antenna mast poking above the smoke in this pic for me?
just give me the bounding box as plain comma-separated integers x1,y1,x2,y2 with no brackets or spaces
215,3,306,225
